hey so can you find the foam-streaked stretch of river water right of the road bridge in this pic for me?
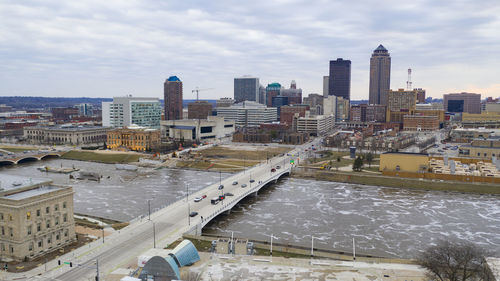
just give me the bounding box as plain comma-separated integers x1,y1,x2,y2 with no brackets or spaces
203,178,500,258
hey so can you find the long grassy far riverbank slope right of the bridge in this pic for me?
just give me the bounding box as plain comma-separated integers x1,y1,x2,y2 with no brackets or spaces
292,168,500,194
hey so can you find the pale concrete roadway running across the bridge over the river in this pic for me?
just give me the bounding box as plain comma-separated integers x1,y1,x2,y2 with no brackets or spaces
0,144,310,281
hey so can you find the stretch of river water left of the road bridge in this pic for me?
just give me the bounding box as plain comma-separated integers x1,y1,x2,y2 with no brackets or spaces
0,159,229,221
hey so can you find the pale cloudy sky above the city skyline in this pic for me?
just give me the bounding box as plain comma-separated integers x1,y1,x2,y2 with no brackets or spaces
0,0,500,99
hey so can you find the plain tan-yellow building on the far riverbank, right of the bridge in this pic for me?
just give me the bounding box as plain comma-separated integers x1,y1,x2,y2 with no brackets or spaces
379,152,429,173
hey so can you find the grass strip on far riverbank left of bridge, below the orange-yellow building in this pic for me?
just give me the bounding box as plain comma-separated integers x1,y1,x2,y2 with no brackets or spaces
61,150,141,164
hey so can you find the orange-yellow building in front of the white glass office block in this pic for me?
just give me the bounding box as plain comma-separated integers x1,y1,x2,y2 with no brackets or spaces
106,126,160,151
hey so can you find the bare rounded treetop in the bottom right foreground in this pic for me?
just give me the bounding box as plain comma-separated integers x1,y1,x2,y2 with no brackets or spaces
417,240,494,281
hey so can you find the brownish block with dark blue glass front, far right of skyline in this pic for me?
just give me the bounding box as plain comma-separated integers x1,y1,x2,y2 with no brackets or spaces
443,92,481,114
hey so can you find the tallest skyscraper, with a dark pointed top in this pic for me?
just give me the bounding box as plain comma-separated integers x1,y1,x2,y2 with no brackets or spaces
370,45,391,105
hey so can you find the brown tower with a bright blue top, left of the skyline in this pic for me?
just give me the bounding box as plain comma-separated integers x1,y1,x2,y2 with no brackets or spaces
163,76,182,120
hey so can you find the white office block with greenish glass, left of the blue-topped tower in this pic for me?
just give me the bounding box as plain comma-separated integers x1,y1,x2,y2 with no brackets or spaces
102,96,161,129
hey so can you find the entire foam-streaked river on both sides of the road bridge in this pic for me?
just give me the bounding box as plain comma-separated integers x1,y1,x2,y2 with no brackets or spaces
0,159,500,258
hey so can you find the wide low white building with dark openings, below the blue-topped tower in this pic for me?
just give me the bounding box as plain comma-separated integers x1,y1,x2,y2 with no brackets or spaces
161,115,235,141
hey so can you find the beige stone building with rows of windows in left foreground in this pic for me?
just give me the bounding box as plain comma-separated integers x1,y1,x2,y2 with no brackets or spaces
0,174,76,261
